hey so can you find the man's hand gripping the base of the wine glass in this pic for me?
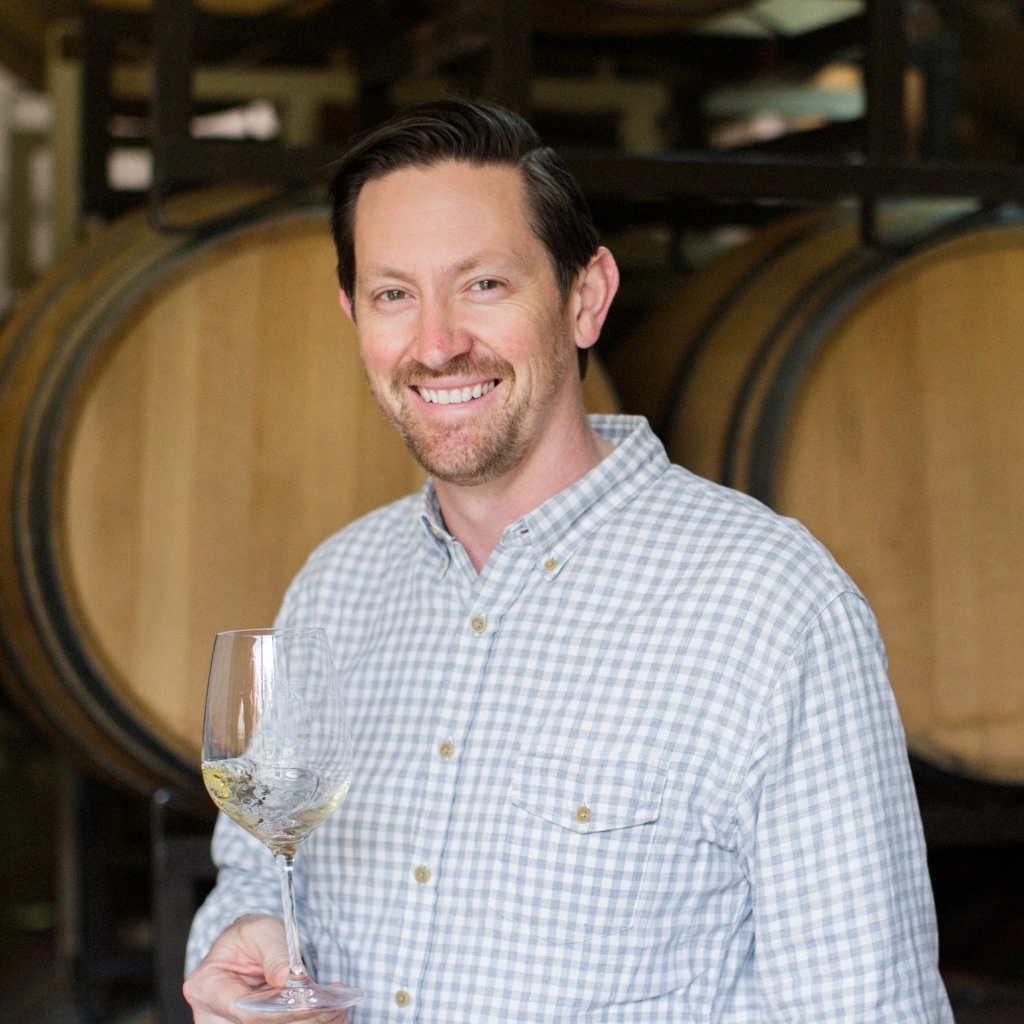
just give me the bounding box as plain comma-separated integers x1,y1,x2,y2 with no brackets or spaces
183,913,348,1024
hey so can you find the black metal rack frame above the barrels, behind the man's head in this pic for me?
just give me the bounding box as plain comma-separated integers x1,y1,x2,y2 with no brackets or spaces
136,0,1024,219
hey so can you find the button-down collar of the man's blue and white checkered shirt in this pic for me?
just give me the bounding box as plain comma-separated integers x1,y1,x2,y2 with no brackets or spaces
411,415,670,579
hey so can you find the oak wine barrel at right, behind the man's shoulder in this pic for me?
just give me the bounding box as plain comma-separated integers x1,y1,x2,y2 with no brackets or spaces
609,204,1024,785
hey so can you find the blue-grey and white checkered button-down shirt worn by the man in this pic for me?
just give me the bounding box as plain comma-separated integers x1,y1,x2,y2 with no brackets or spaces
189,417,952,1024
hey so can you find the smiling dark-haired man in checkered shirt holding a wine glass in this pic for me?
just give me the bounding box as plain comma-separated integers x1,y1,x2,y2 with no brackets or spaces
185,102,951,1024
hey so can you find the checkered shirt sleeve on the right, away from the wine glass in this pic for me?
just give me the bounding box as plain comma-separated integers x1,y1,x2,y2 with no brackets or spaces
744,593,952,1024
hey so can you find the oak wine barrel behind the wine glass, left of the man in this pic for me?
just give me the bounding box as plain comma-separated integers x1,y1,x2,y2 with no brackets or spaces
0,189,617,793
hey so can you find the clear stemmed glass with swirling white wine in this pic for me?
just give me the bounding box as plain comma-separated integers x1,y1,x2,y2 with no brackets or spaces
203,628,364,1014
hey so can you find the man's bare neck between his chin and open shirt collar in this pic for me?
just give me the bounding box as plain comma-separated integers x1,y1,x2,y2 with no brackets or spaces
434,420,613,572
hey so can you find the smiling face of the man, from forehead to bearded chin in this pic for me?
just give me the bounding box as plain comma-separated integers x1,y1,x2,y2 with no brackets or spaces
342,162,580,484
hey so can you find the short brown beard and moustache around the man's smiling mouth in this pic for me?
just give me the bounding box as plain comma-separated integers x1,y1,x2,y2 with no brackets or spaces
371,324,577,485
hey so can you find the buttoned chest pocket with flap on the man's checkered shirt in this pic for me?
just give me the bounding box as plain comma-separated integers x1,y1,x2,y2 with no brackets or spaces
489,755,666,945
